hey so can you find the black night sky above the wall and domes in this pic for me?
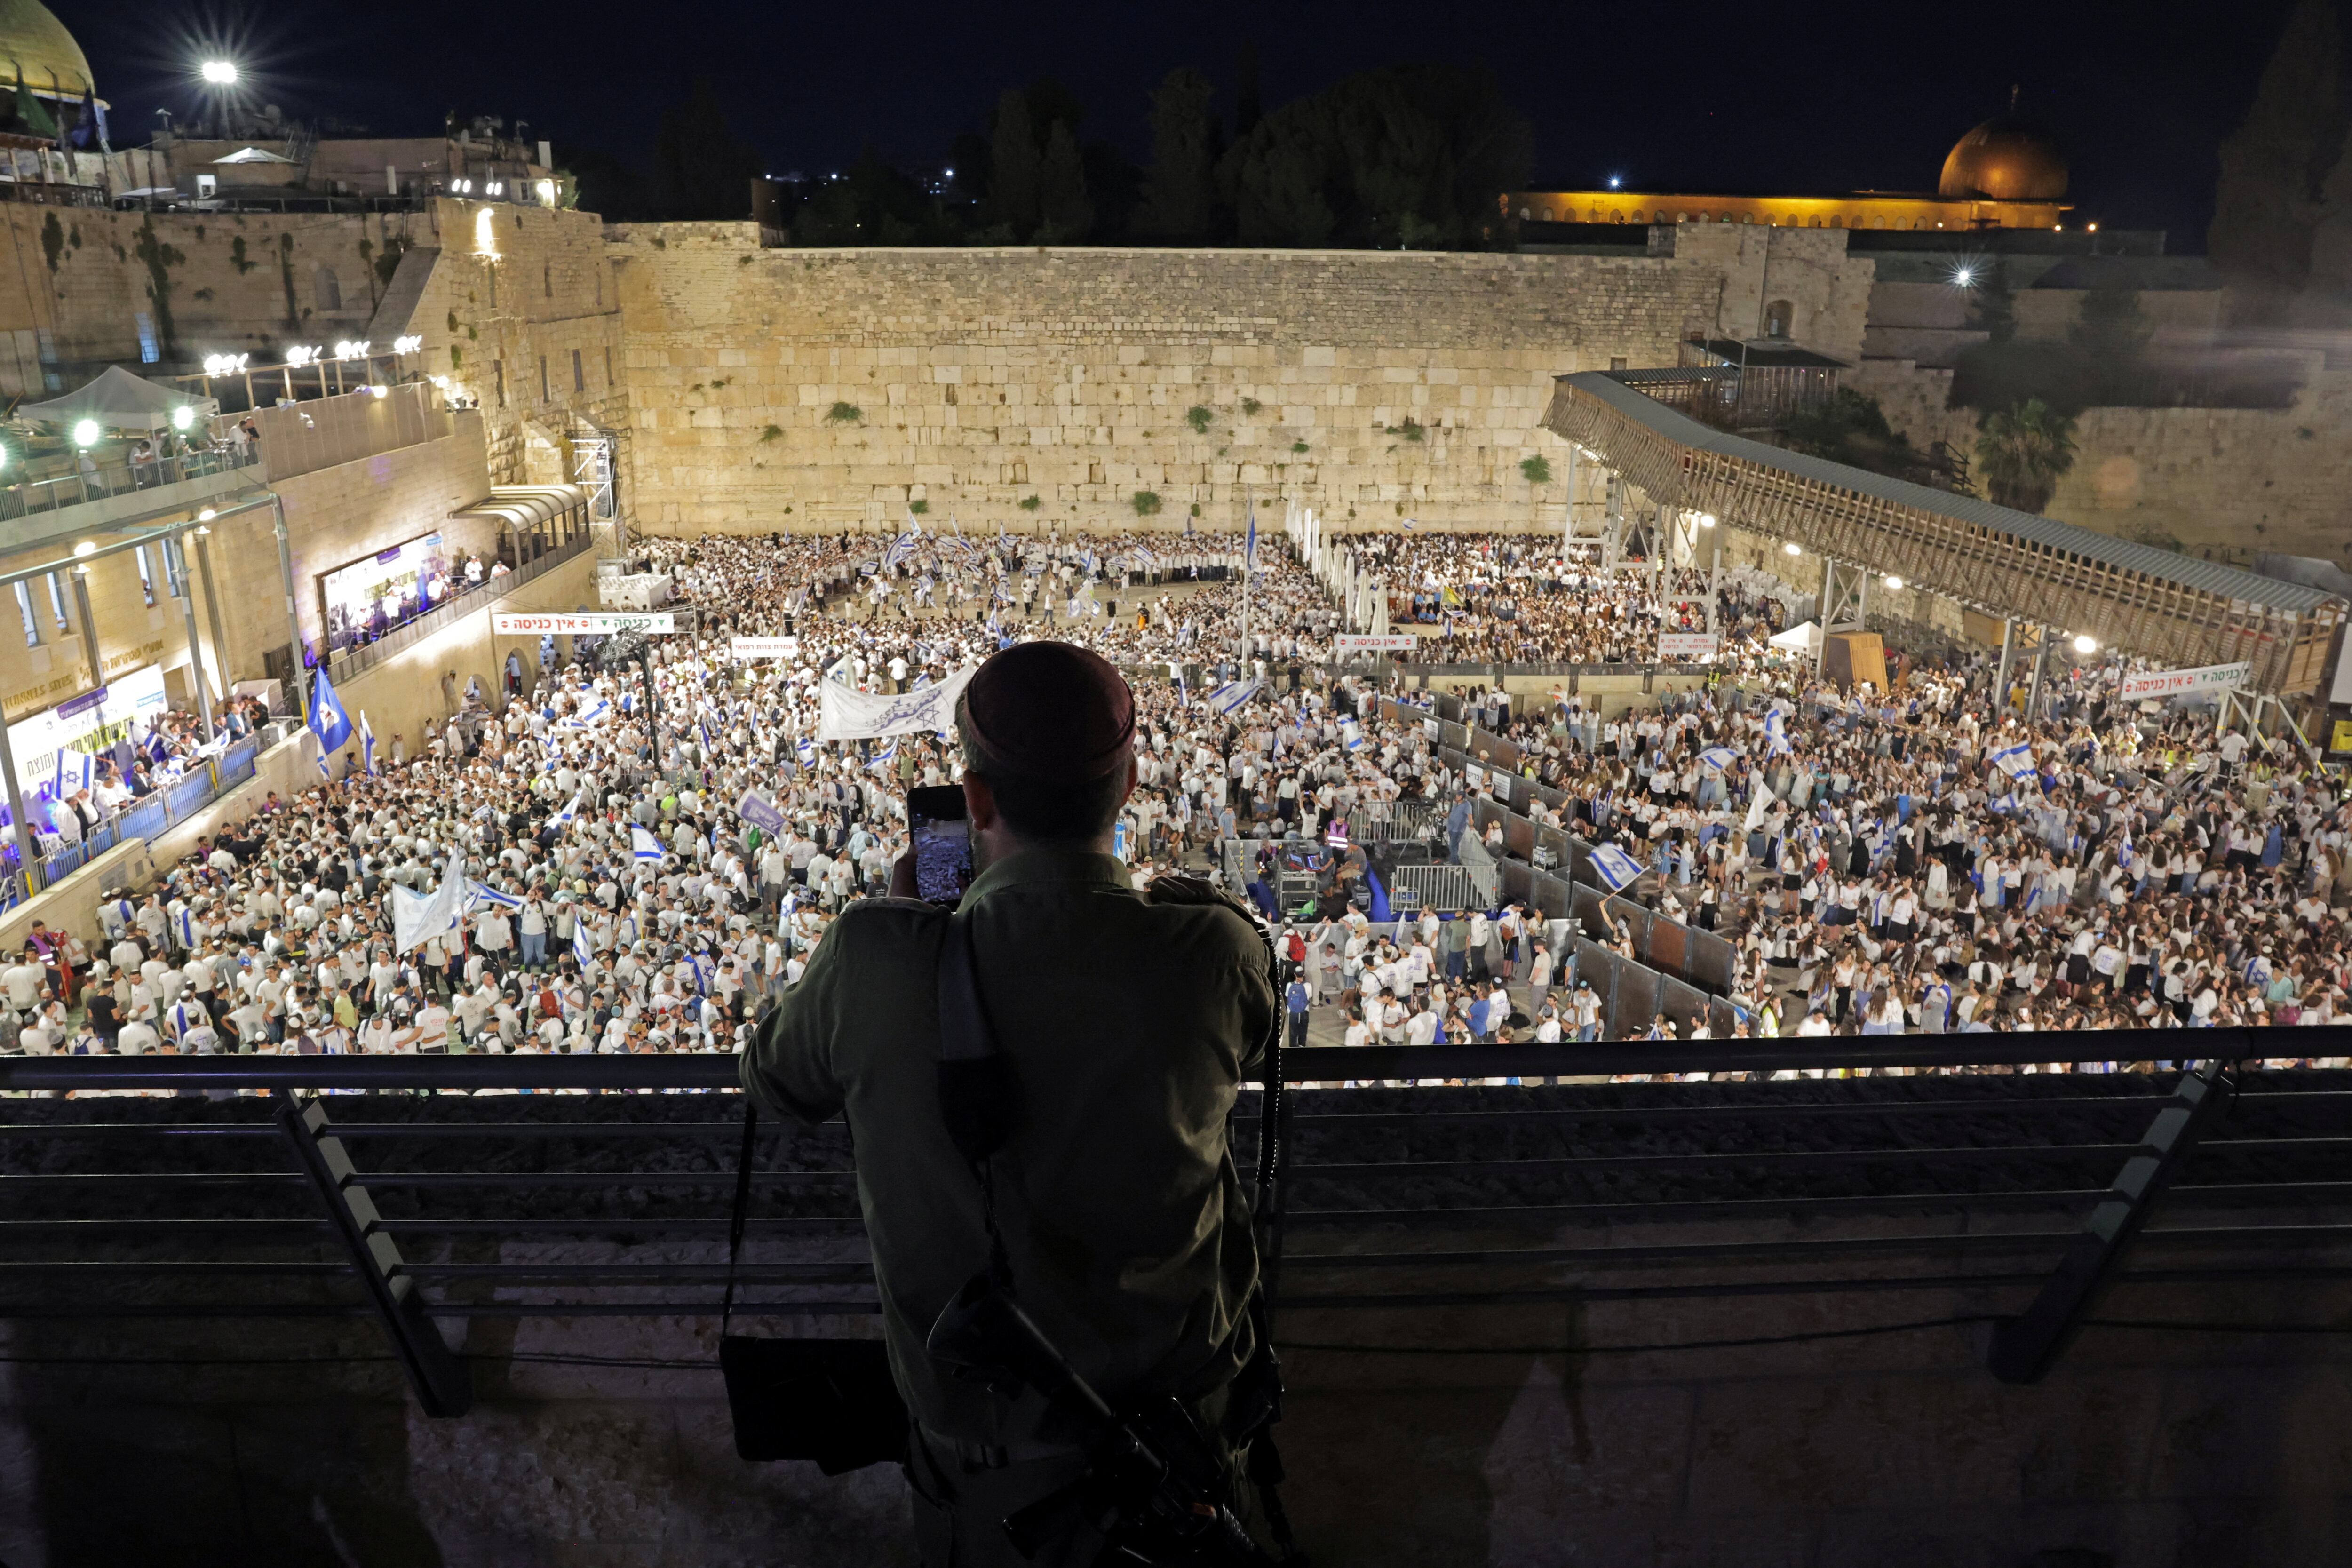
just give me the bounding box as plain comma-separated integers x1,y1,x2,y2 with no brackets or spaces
56,0,2288,252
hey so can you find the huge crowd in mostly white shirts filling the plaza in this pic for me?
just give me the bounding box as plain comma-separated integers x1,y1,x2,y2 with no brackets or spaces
0,529,2352,1072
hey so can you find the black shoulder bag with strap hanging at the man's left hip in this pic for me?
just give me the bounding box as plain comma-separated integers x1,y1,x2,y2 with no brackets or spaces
720,1093,906,1476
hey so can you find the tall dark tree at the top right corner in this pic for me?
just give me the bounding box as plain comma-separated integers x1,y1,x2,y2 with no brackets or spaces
2206,0,2347,296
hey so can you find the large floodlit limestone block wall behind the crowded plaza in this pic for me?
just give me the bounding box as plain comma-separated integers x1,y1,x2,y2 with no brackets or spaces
609,223,1870,533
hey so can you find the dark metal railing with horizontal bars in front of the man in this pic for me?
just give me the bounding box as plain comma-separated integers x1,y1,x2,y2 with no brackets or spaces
0,1043,2352,1415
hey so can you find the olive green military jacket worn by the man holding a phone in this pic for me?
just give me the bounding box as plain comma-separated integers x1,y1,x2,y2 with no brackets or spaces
743,849,1279,1443
